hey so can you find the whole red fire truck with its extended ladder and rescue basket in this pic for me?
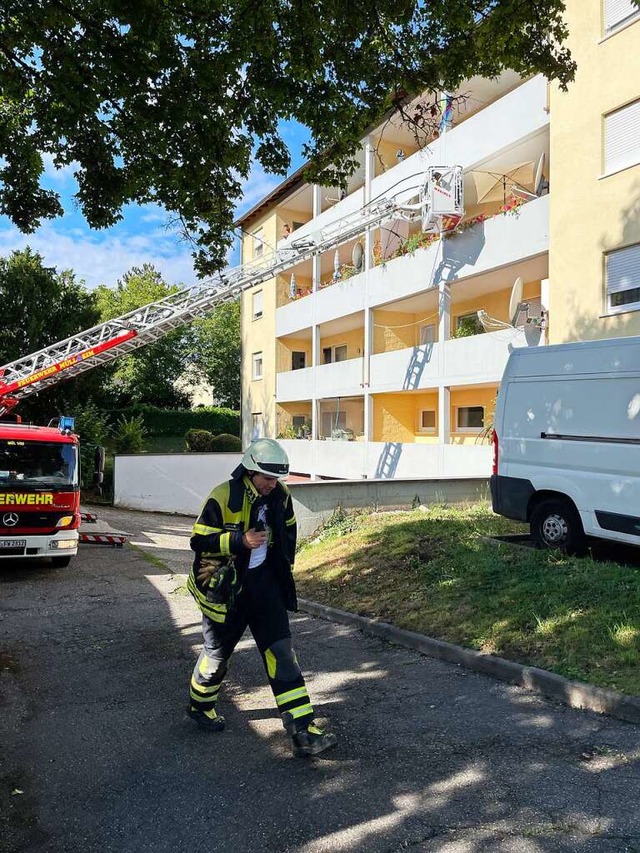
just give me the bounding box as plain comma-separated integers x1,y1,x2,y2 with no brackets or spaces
0,166,463,566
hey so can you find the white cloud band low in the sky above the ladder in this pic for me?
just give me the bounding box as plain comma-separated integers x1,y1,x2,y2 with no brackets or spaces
0,223,196,289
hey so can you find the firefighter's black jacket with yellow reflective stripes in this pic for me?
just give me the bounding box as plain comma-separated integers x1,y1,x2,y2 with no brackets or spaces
187,469,298,622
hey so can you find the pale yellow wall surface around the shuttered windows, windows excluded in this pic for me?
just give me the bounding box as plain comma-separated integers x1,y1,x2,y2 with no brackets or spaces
549,0,640,343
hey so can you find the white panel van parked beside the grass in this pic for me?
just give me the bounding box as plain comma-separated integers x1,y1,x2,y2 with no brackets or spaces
491,337,640,553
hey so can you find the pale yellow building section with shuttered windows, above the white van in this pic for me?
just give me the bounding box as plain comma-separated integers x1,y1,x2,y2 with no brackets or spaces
549,0,640,343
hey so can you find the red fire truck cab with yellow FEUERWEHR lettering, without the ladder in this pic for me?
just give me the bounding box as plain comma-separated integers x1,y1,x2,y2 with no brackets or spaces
0,418,80,566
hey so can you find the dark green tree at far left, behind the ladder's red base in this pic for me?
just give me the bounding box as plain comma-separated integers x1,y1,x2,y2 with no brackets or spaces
0,248,104,423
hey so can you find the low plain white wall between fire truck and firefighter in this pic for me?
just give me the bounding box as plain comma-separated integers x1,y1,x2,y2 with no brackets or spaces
114,453,242,516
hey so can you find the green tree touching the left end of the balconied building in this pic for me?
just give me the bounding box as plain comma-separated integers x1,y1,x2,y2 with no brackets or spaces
191,301,241,409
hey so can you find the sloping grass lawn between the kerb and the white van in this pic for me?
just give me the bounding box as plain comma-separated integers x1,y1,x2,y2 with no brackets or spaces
296,504,640,695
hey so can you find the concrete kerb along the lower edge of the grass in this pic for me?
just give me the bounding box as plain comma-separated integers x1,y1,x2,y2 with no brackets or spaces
299,599,640,725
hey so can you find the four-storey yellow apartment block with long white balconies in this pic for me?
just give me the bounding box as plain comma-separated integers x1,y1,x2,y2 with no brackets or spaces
237,73,554,479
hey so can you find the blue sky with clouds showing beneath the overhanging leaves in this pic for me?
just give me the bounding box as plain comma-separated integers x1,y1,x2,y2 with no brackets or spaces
0,122,308,288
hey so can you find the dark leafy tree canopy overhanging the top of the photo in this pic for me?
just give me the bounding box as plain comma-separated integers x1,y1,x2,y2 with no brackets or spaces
0,0,574,273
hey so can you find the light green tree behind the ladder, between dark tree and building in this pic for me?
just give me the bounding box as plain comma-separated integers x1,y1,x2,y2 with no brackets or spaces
95,264,190,408
